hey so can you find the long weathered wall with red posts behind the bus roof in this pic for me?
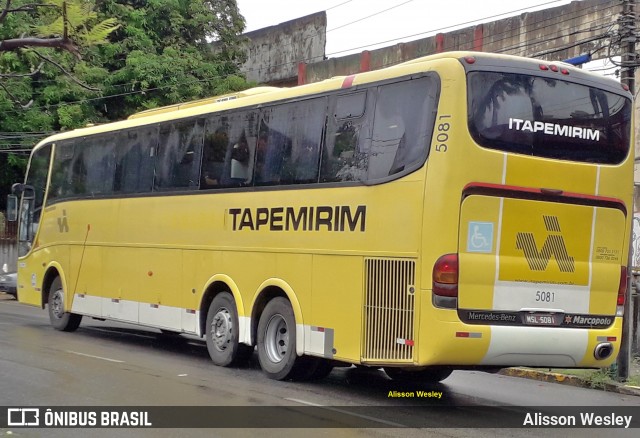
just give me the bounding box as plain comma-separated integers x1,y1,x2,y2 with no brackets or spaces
298,0,622,83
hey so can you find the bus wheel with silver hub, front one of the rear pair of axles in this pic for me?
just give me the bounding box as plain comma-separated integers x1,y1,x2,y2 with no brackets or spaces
205,292,253,367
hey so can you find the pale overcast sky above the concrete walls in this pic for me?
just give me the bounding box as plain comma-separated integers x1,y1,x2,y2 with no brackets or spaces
237,0,569,58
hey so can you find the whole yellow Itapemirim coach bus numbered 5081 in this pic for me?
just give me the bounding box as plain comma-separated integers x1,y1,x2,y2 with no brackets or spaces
7,52,633,381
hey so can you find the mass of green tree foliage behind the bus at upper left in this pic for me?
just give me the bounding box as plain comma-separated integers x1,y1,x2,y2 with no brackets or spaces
0,0,248,205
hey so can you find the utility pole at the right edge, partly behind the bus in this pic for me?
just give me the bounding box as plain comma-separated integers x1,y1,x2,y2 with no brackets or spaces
617,0,637,381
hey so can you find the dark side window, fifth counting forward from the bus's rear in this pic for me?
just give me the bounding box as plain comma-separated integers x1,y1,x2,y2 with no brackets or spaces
154,120,204,190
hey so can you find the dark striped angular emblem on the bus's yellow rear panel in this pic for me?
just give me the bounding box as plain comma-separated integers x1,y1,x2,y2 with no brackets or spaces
516,216,575,272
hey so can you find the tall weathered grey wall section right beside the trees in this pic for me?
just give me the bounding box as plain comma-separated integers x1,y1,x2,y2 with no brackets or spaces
241,11,327,86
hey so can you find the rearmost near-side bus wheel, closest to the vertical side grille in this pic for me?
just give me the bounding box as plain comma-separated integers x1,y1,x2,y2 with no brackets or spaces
257,297,307,380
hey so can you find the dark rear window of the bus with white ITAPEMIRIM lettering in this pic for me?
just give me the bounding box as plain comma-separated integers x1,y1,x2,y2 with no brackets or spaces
468,71,631,164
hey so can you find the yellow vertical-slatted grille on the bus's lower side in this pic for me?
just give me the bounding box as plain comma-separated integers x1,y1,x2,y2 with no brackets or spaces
362,258,416,363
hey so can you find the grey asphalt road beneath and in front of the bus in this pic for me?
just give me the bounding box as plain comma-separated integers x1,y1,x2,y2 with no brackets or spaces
0,299,640,438
